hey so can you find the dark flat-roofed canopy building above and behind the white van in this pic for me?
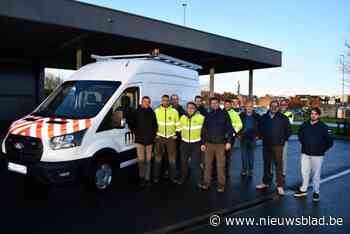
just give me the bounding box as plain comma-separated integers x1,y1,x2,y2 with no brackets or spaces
0,0,282,132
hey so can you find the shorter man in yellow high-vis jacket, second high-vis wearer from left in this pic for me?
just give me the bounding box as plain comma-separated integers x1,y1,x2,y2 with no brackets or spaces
180,102,204,184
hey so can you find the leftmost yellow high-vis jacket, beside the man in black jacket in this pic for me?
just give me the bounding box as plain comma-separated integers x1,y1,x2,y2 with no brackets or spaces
154,106,180,138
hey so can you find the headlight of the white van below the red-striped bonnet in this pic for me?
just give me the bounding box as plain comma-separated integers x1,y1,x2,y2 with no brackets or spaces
50,129,86,150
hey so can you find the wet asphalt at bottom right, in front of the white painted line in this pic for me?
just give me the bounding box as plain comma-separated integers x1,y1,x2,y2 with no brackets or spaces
185,174,350,234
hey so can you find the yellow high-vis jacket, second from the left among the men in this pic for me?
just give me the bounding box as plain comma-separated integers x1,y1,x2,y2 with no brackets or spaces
180,112,204,143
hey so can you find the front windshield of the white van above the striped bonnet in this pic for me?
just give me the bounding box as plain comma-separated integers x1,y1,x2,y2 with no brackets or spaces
32,80,121,119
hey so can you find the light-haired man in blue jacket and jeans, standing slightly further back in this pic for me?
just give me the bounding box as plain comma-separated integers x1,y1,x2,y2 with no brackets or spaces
238,101,260,177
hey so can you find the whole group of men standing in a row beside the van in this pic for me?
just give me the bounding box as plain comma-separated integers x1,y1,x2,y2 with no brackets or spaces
130,95,332,200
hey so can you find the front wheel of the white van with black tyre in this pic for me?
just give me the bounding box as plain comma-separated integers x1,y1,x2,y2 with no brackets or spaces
91,159,113,191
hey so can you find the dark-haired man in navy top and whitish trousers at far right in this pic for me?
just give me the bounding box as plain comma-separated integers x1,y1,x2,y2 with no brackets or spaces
294,108,333,202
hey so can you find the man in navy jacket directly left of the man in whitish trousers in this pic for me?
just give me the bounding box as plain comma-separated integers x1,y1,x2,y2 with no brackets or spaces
256,101,292,196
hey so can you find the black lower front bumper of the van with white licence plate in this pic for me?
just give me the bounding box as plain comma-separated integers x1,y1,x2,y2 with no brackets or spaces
4,155,90,184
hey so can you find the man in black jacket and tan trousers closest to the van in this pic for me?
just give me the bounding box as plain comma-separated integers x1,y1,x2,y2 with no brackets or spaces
132,96,158,186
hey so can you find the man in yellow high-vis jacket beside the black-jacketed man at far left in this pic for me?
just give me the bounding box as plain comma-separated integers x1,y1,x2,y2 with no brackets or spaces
153,95,180,184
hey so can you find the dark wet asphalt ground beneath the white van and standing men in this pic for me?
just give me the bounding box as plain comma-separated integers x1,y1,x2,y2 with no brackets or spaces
0,141,350,234
